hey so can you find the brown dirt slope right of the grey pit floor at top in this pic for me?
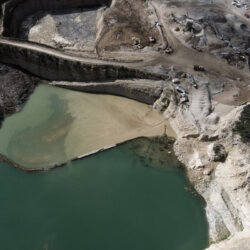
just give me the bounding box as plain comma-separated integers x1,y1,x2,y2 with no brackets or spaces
96,0,159,54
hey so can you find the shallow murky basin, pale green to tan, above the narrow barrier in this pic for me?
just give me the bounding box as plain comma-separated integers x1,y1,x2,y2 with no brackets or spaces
0,85,170,168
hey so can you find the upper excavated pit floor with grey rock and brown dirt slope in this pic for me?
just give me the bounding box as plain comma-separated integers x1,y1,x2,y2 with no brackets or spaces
19,0,160,57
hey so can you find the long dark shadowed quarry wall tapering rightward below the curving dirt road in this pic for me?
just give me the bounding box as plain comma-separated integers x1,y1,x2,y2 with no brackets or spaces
0,42,167,82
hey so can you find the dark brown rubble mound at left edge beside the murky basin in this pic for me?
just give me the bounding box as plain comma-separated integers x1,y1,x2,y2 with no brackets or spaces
0,64,35,115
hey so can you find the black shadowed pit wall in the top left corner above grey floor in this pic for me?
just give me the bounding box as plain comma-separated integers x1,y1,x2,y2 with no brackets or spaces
0,0,111,37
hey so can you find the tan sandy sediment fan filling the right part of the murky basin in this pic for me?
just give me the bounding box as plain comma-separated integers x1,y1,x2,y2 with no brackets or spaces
65,92,173,156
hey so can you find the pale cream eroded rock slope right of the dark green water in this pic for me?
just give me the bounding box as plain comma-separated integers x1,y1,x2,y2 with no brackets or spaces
162,91,250,246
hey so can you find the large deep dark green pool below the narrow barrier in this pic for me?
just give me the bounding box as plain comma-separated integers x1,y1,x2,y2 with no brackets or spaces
0,140,208,250
